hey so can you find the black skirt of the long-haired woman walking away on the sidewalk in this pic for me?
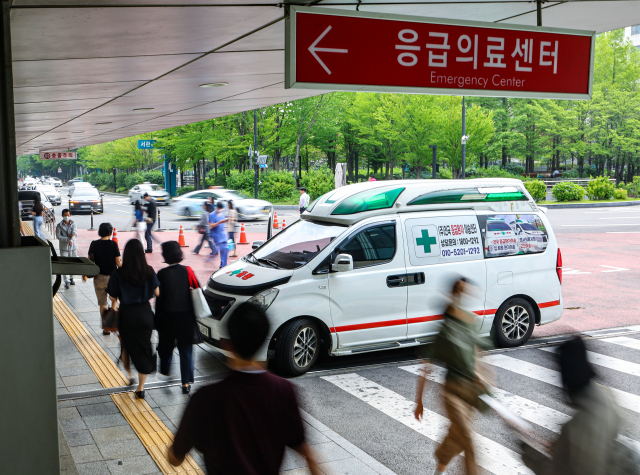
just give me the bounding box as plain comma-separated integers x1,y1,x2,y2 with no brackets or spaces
118,302,156,374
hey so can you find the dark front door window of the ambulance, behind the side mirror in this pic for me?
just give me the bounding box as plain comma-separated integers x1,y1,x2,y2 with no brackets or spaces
340,224,396,269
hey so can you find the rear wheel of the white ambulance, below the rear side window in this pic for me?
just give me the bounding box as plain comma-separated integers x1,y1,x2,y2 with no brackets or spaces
493,298,536,348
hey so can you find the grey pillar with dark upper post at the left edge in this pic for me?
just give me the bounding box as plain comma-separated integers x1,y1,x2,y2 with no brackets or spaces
0,0,60,475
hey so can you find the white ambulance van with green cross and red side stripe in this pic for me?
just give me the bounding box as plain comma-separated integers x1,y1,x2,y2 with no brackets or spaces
198,178,562,375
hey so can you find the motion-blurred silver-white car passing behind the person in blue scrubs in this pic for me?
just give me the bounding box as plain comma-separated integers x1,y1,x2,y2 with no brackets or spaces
172,188,273,221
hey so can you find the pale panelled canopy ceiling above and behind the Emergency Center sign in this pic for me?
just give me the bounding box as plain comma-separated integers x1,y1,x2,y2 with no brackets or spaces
11,0,640,155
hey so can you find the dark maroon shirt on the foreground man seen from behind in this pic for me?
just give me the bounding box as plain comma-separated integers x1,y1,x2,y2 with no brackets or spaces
173,371,304,475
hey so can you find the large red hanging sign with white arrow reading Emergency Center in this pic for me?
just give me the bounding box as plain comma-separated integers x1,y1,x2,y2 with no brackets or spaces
286,6,595,99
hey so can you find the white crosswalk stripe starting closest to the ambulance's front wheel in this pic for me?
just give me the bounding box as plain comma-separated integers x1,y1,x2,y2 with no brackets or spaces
322,373,531,475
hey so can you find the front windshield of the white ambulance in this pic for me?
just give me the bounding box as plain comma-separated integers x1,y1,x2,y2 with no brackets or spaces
247,220,347,269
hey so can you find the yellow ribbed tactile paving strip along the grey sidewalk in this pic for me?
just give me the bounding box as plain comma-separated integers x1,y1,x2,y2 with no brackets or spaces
53,296,204,475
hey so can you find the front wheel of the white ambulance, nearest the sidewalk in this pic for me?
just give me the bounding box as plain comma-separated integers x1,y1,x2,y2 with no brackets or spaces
276,318,320,376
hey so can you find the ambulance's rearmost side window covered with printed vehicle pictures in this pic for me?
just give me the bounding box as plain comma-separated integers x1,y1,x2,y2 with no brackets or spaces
478,213,549,258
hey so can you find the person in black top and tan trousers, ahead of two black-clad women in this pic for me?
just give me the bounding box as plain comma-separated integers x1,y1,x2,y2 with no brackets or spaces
89,223,122,335
